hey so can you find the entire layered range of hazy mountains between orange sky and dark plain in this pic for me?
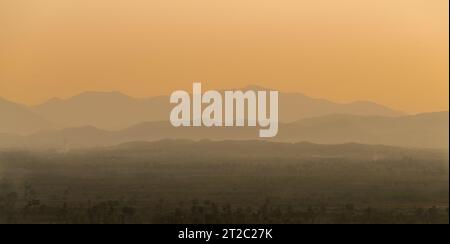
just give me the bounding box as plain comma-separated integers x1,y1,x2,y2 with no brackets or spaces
0,87,449,148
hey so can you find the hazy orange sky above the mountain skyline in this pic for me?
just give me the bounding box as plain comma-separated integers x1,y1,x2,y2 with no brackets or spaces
0,0,449,112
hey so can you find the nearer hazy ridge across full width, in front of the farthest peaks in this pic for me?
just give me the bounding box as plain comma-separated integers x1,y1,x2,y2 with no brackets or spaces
0,112,449,149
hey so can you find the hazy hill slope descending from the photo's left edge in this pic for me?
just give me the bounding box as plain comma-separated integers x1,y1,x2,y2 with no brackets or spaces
0,98,53,134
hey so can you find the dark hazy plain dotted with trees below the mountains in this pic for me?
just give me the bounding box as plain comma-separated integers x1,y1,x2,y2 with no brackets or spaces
0,141,449,224
